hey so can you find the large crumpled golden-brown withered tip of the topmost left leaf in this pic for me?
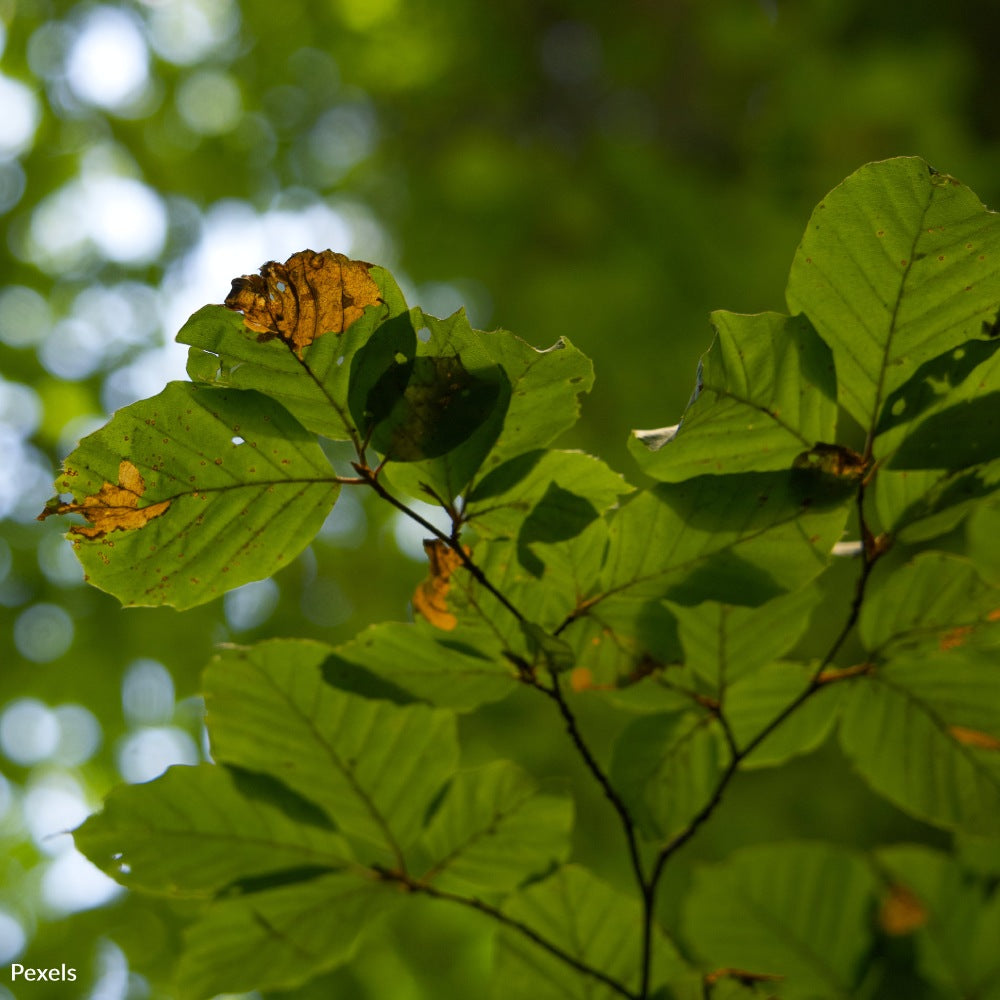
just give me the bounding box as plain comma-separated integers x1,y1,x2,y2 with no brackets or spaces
225,250,381,360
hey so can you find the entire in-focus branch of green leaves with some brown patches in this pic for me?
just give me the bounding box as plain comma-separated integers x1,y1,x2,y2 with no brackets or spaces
43,158,1000,1000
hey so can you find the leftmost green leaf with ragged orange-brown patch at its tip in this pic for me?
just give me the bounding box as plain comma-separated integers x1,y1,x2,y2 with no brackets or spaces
42,382,340,609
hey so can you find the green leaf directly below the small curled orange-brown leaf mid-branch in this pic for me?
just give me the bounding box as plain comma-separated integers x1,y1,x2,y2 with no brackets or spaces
327,621,518,712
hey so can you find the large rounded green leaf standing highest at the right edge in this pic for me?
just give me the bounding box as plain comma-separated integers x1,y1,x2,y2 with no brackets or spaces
786,157,1000,430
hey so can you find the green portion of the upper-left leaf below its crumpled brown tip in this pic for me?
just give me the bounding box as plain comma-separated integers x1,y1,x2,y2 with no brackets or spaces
177,267,406,440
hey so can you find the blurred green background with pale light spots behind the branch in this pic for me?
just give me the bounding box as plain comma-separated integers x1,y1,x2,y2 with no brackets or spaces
0,0,1000,1000
